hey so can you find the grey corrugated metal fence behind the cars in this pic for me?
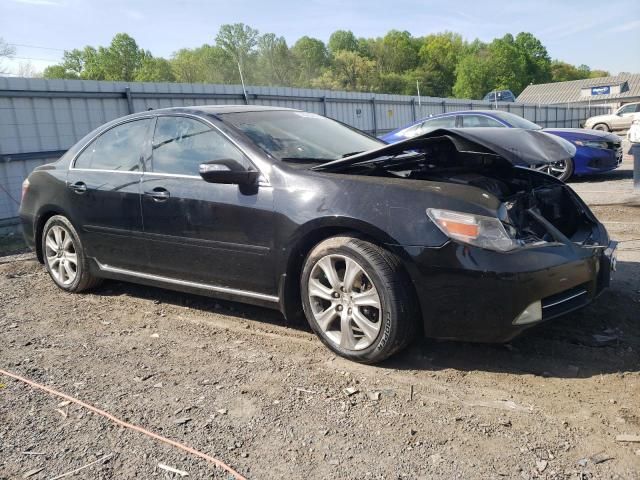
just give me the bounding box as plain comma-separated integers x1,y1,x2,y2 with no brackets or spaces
0,77,608,223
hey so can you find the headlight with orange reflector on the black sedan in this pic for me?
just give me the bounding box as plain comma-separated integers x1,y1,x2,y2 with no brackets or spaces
427,208,521,252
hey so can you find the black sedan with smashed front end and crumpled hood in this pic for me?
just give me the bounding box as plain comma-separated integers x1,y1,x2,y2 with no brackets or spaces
20,106,615,362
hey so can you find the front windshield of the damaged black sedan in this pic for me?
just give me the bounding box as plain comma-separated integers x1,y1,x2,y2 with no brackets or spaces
219,110,384,162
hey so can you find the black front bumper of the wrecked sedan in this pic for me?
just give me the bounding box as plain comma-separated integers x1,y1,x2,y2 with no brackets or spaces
407,235,615,342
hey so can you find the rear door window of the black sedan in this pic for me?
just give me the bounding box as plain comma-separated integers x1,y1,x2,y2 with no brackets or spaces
74,119,151,172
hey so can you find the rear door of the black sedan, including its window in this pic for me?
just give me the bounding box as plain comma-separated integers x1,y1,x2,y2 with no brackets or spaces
65,118,153,268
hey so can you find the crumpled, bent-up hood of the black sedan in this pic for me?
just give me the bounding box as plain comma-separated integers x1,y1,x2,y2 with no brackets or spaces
313,127,576,171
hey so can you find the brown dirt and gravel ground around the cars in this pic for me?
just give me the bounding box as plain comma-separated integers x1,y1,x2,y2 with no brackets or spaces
0,160,640,479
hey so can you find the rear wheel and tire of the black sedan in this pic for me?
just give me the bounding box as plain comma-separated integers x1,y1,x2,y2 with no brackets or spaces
42,215,101,292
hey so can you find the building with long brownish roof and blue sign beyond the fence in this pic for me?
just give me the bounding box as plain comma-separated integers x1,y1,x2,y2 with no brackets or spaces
517,73,640,108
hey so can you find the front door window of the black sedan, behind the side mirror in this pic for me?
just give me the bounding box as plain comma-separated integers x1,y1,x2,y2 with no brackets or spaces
147,117,251,175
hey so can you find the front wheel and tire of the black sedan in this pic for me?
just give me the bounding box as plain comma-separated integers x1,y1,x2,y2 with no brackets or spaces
301,236,417,363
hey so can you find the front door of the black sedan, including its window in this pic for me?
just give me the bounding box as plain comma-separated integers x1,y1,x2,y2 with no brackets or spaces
142,116,276,294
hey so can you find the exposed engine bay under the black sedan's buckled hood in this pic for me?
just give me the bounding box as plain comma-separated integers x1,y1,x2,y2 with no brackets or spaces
332,138,597,245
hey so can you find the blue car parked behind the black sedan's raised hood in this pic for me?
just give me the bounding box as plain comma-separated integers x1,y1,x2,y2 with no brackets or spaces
380,110,622,181
